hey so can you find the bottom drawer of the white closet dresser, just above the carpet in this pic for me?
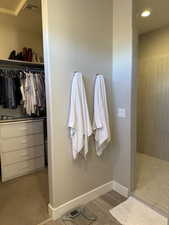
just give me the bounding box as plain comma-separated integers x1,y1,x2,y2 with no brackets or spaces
2,157,44,181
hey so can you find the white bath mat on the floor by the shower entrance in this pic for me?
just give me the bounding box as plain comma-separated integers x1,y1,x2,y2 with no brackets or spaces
110,197,168,225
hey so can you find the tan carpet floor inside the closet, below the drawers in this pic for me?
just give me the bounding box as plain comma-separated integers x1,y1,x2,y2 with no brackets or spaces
0,169,49,225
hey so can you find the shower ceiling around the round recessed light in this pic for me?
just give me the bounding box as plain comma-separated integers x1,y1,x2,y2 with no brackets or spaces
135,0,169,33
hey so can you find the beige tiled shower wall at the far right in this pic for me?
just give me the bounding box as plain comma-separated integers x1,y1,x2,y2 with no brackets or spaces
138,26,169,160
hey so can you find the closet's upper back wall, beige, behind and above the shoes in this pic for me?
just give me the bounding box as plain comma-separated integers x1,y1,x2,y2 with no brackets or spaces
0,11,43,59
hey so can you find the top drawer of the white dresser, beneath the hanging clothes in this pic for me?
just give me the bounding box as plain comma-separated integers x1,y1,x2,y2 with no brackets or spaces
0,121,43,138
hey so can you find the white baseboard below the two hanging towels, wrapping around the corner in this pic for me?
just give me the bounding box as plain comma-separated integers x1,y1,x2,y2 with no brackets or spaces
48,181,128,220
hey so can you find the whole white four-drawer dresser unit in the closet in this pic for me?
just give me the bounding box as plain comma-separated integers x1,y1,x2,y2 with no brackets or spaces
0,120,45,182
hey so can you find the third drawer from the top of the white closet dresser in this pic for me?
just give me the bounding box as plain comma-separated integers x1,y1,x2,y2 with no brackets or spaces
1,145,44,166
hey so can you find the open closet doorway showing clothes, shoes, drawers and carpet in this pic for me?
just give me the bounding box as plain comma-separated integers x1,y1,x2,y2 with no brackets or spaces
0,0,49,225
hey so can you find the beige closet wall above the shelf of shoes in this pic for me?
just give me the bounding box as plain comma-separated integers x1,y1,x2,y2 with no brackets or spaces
0,14,43,59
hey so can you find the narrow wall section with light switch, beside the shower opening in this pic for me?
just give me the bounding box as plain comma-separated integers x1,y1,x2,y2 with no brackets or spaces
113,0,135,190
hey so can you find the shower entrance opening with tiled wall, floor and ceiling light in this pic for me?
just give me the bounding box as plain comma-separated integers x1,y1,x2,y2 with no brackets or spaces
134,0,169,215
